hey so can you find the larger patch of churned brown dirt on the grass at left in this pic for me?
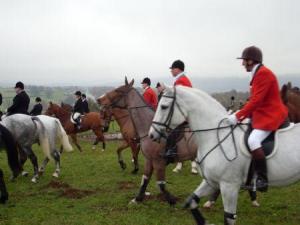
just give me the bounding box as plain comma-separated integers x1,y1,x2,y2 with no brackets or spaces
42,181,96,199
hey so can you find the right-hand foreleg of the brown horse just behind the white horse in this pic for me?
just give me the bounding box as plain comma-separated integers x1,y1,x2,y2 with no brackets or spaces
153,160,176,205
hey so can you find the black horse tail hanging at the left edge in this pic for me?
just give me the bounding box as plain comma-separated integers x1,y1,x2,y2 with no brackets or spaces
0,124,22,177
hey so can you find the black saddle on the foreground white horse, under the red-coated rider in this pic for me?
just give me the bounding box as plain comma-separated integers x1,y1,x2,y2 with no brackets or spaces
244,118,290,157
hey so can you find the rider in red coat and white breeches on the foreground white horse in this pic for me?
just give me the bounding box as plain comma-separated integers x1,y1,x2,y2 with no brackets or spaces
227,46,288,191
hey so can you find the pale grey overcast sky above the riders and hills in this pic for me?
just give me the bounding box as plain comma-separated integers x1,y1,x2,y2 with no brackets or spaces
0,0,300,85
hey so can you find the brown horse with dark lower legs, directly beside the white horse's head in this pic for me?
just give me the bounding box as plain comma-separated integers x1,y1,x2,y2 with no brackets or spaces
97,79,197,204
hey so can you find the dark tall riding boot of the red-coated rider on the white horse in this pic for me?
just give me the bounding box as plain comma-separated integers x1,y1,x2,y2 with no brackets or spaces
251,148,268,192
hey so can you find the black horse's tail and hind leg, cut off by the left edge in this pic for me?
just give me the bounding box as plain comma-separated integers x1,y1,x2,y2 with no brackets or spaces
0,124,22,204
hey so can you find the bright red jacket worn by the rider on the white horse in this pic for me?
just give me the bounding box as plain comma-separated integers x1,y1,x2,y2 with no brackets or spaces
236,65,288,131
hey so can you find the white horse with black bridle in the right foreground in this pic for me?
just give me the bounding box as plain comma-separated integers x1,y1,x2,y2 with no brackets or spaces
149,86,300,225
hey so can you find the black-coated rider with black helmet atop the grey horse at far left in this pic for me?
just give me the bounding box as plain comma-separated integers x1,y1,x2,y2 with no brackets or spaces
7,82,30,116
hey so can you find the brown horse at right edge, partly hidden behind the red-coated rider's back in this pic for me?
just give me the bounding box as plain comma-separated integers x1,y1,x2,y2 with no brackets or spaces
281,82,300,123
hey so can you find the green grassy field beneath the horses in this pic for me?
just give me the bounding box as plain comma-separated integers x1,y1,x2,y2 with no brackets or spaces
0,142,300,225
